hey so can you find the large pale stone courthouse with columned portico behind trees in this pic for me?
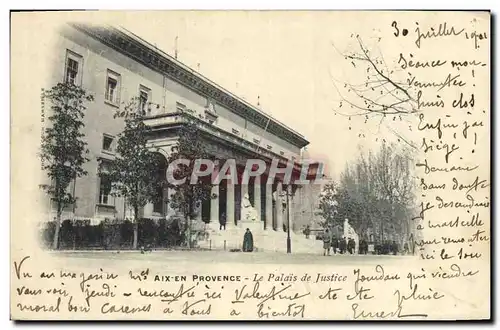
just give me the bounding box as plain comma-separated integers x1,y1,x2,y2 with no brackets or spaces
45,24,322,240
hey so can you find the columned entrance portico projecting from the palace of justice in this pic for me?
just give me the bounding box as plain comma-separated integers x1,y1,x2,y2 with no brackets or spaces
146,109,308,238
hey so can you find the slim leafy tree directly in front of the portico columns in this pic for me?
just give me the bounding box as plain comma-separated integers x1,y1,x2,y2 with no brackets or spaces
169,114,212,248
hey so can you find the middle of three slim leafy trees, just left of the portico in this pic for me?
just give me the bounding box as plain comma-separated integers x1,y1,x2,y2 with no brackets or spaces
107,99,163,249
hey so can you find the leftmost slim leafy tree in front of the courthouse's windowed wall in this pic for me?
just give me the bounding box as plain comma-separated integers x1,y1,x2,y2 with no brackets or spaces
40,83,93,249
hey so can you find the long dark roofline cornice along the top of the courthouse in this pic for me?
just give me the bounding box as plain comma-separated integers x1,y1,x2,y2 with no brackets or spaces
71,23,309,148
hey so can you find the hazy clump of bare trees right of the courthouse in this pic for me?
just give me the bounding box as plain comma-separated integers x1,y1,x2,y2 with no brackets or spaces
320,144,416,244
